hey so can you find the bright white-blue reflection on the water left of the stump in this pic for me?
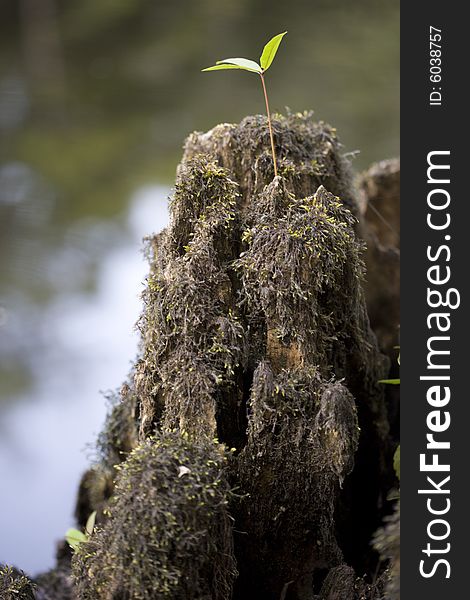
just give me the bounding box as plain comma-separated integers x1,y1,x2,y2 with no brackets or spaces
0,187,168,573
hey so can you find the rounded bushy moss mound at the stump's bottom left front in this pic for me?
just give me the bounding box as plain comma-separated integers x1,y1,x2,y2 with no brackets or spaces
73,433,236,600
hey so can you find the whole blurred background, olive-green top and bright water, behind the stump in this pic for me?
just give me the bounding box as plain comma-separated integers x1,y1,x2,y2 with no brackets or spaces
0,0,399,574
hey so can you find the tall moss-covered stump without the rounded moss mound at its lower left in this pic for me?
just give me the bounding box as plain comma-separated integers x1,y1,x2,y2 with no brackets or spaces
123,114,392,600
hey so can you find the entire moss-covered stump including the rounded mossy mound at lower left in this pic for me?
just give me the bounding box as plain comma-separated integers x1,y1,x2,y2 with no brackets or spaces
39,113,393,600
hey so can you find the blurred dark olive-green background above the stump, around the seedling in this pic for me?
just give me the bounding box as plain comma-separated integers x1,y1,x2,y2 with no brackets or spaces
0,0,399,220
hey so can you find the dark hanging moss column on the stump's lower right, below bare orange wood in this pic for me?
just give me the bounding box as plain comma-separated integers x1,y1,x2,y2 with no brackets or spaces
237,362,359,597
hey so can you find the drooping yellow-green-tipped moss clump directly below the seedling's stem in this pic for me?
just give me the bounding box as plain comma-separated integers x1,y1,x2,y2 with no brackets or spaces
235,179,363,375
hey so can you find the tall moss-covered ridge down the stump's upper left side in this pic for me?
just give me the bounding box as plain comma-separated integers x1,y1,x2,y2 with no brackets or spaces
135,157,244,436
